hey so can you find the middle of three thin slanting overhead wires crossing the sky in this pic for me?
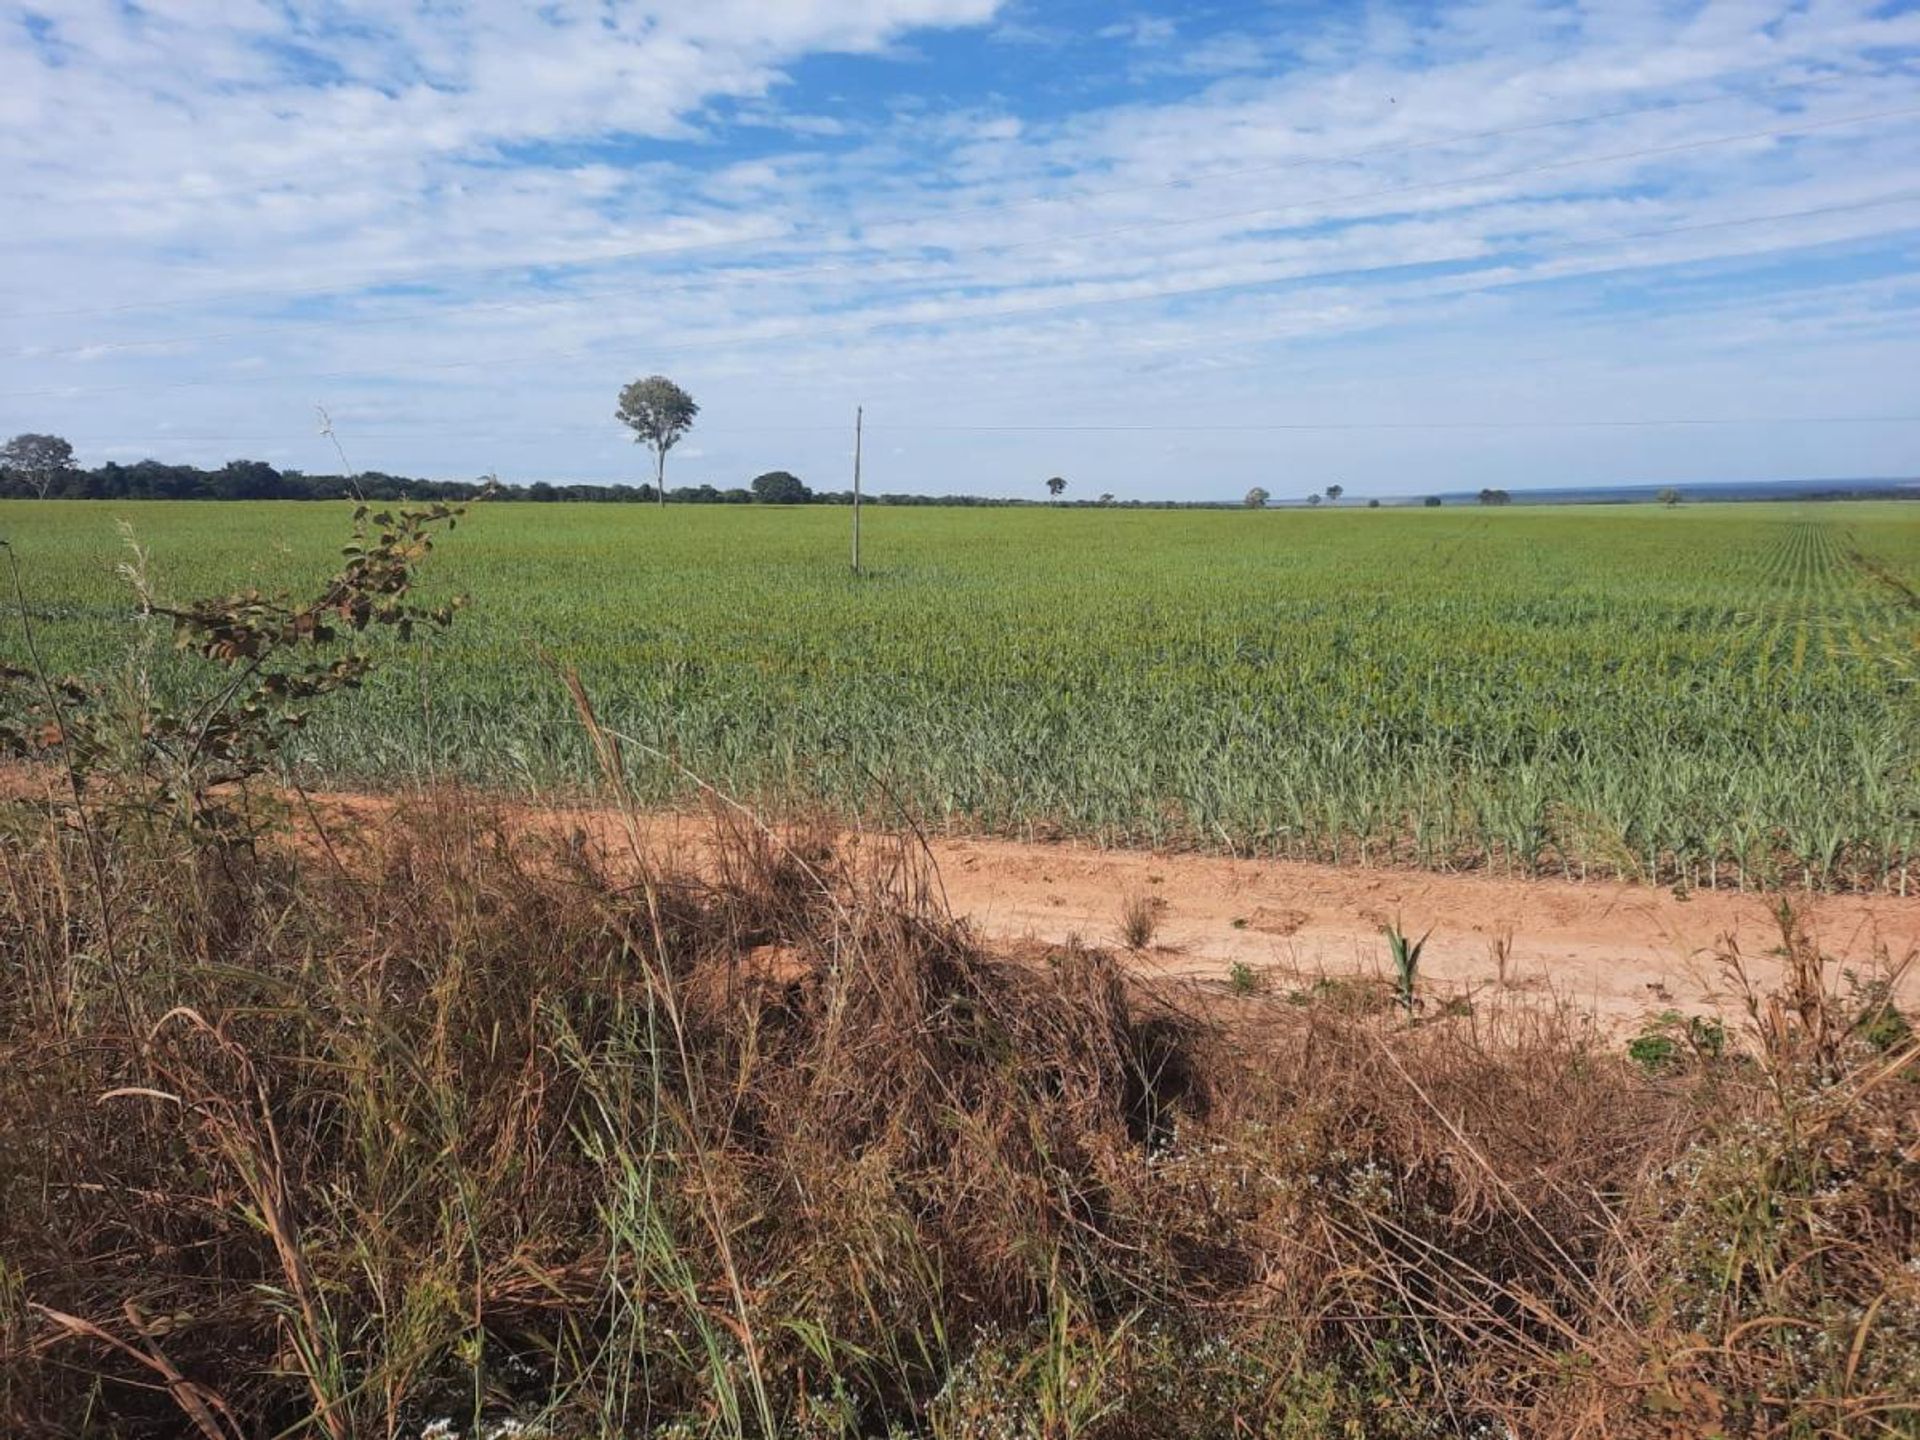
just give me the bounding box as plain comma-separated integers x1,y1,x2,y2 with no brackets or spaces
19,106,1920,372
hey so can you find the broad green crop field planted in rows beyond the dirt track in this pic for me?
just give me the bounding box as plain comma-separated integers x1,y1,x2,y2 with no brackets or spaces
0,501,1920,887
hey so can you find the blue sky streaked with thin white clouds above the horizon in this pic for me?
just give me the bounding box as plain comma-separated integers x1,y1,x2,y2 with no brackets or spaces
0,0,1920,501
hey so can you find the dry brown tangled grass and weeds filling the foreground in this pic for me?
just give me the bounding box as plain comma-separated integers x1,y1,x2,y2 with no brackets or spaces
0,795,1920,1440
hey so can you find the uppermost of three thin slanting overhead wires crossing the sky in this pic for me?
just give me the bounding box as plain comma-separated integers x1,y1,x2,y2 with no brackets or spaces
0,69,1905,321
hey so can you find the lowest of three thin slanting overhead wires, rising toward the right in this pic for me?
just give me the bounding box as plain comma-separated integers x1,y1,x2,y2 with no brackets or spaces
0,183,1920,399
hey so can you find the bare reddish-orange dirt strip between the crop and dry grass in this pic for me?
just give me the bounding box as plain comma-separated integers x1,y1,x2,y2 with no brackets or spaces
323,795,1920,1029
